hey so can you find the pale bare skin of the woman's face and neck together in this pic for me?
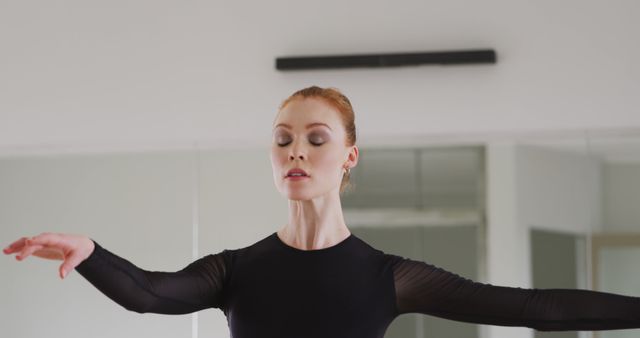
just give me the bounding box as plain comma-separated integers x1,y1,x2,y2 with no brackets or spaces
271,98,358,250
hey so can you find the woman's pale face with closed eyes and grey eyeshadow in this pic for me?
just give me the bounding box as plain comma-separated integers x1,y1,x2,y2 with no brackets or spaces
271,98,358,200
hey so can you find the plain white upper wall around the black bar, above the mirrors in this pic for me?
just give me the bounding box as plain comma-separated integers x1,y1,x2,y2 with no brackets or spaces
0,0,640,152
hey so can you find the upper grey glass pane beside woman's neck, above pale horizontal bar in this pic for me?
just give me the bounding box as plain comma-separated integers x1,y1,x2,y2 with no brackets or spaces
342,147,484,209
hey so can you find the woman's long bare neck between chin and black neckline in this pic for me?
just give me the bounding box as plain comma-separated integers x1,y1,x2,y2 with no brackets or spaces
278,191,351,250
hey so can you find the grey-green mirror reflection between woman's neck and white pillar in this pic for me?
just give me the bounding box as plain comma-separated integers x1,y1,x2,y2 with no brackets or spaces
342,146,485,338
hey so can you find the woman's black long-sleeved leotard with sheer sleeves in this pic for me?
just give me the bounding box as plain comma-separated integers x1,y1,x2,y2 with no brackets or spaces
76,233,640,338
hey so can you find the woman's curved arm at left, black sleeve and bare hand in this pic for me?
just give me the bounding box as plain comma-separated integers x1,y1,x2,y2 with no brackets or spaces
3,233,232,314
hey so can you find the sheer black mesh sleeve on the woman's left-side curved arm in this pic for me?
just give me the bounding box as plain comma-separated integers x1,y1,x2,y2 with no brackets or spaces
76,241,230,314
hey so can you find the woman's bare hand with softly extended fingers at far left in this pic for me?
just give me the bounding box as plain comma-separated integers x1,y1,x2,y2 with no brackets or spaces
2,232,95,278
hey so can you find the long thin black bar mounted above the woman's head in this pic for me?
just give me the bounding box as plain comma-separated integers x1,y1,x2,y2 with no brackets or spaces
276,49,496,70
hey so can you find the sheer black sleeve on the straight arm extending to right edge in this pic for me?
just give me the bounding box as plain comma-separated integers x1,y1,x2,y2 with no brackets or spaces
391,255,640,331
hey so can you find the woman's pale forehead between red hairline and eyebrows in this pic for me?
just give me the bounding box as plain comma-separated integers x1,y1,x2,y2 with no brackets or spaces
274,98,341,131
